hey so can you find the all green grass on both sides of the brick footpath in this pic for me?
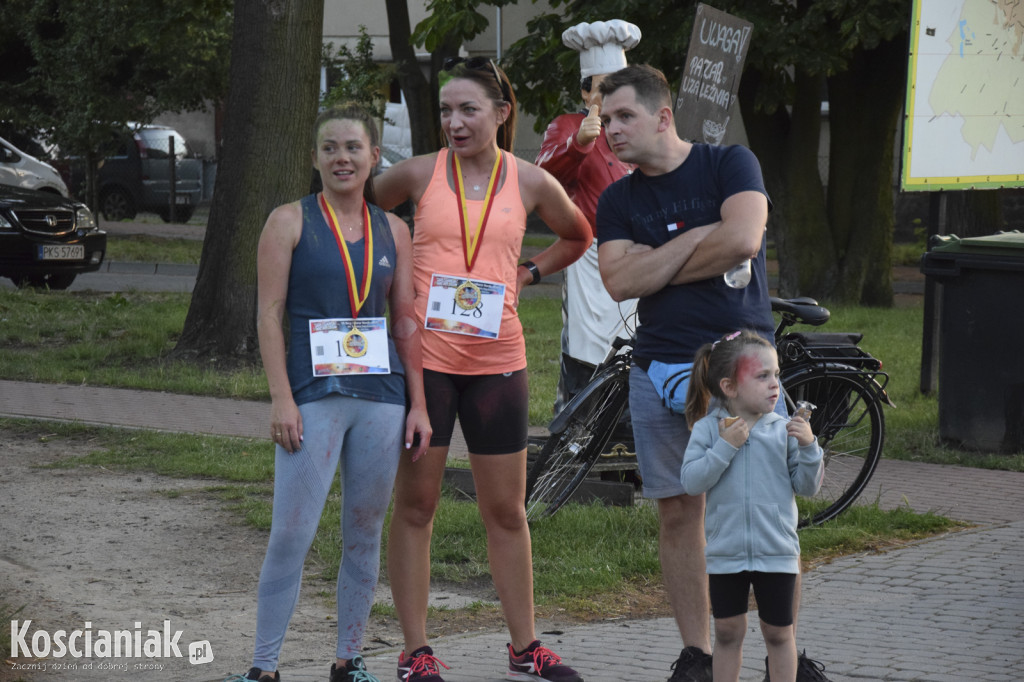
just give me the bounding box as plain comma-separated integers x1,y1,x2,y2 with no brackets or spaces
0,232,1011,613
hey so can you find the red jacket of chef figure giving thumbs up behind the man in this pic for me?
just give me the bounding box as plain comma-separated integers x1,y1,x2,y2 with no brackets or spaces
537,114,634,237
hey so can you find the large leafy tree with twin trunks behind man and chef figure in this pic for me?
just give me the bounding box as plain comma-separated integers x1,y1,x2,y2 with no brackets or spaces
506,0,910,305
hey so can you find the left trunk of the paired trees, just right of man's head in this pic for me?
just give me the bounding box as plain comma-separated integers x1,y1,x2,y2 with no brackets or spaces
739,70,836,296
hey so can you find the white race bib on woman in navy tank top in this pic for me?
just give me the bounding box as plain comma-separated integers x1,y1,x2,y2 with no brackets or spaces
309,317,391,377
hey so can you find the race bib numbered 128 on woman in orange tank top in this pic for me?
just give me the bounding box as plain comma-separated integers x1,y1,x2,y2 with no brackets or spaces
424,274,505,339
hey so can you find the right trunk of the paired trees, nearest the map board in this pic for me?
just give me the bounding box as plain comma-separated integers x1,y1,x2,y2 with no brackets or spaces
827,34,906,306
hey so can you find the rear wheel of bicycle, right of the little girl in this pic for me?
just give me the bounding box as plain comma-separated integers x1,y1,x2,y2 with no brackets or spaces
783,368,885,527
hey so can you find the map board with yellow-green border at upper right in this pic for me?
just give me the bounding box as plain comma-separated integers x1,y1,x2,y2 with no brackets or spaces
900,0,1024,191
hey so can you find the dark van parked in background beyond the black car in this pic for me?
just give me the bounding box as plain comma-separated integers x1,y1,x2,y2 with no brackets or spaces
68,125,203,222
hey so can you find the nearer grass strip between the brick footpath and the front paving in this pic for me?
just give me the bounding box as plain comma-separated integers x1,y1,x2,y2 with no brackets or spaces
0,419,957,619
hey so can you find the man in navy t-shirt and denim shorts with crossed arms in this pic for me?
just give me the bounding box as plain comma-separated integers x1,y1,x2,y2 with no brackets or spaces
597,65,773,681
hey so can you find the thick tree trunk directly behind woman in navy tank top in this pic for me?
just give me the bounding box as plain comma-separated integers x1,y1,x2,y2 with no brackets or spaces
174,0,324,361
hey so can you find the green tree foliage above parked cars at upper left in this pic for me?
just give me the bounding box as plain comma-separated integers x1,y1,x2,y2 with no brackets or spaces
0,0,232,208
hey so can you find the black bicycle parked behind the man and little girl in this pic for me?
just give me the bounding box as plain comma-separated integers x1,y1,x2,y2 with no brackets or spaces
526,297,895,526
